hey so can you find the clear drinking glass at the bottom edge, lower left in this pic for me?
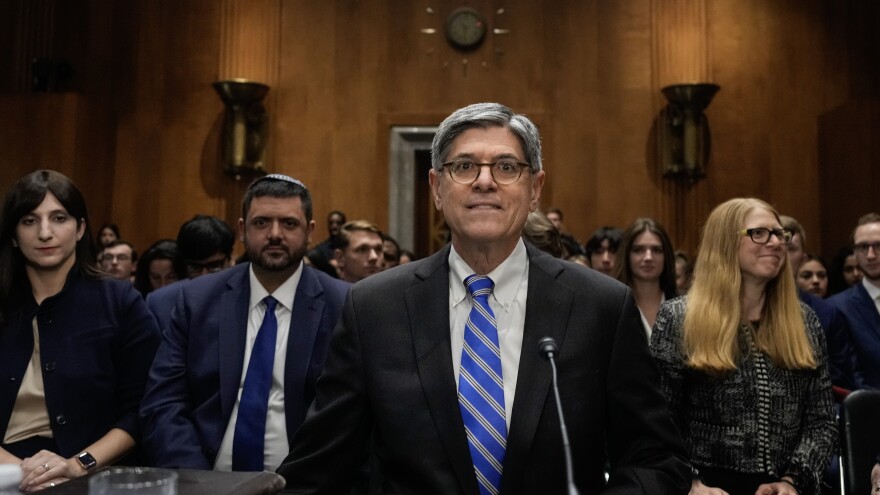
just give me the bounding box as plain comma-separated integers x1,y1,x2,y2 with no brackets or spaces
89,467,177,495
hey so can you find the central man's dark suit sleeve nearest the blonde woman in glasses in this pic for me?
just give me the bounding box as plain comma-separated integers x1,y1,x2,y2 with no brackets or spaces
603,290,691,495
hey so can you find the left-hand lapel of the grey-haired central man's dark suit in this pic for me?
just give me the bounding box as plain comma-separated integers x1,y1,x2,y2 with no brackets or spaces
404,245,477,494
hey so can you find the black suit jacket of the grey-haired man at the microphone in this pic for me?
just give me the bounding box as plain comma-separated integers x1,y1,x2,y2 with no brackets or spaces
278,245,691,494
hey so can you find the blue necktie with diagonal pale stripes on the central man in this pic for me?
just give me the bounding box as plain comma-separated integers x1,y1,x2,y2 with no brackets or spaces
458,275,507,495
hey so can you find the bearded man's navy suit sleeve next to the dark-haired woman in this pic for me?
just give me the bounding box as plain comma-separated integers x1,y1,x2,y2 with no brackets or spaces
141,291,213,469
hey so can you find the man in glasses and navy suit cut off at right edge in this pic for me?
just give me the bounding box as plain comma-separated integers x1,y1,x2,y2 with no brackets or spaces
829,213,880,388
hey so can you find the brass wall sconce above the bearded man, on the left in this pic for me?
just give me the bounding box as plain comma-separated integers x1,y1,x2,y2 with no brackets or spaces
213,79,269,180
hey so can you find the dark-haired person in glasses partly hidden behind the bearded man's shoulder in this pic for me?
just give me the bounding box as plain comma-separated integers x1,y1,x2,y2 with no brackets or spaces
147,215,235,331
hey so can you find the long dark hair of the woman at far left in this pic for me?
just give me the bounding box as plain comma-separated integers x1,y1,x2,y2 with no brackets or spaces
0,170,102,323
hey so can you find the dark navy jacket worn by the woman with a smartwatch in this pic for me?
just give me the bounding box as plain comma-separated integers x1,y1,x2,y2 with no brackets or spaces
0,276,159,460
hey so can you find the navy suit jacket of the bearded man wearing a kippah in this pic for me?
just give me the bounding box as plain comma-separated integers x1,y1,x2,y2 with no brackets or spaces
141,263,349,469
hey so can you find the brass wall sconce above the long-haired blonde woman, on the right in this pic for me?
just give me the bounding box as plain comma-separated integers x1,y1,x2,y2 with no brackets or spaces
658,83,721,183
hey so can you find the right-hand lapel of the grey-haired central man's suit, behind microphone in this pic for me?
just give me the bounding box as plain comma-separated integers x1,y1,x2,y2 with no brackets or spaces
501,248,574,492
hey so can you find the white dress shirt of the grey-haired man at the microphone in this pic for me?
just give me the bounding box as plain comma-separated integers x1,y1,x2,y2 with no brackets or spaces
449,239,524,429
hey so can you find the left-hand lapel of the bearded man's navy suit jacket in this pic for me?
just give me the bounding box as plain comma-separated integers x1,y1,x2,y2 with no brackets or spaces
217,264,251,422
